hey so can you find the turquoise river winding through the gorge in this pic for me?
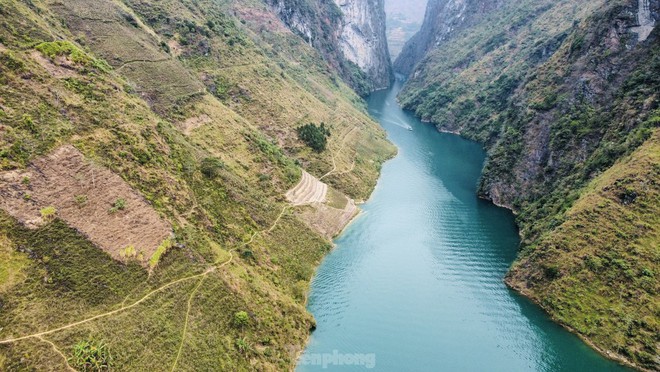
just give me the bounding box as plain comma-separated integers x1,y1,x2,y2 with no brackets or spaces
297,83,624,372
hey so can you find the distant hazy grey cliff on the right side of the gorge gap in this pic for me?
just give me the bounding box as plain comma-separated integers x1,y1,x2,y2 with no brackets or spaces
394,0,502,75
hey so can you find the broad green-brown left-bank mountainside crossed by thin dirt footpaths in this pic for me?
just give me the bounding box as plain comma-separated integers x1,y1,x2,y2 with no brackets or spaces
0,0,394,370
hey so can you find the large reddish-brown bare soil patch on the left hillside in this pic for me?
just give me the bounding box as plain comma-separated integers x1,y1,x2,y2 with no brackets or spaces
0,145,172,266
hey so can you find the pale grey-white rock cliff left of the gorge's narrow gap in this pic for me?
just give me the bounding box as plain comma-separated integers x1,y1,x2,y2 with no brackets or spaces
266,0,392,95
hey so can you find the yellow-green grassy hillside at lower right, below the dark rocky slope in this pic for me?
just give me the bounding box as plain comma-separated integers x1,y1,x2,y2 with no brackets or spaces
507,129,660,368
